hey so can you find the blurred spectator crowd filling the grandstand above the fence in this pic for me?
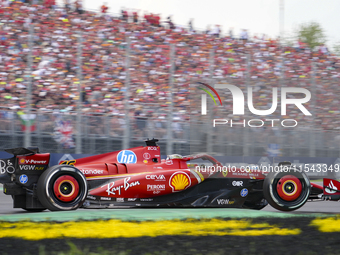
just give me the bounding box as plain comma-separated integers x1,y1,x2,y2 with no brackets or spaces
0,0,340,134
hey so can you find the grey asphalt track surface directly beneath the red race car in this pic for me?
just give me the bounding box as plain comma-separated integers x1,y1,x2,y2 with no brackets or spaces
0,185,340,218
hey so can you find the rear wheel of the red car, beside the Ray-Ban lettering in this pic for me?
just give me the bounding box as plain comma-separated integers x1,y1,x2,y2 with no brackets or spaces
37,165,88,211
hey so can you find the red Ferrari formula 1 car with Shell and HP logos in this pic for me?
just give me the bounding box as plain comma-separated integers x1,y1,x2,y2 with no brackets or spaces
0,139,340,211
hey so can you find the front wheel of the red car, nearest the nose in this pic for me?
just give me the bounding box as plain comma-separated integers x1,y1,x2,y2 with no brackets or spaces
263,168,311,211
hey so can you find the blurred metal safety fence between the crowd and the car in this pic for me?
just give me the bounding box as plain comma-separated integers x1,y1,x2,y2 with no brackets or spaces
0,106,340,157
